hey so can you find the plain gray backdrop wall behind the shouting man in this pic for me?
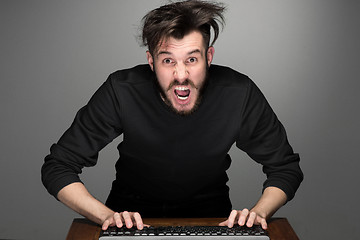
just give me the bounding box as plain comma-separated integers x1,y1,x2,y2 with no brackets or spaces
0,0,360,239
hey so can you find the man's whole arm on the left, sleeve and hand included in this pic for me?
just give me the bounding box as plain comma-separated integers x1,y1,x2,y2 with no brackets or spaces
41,77,146,229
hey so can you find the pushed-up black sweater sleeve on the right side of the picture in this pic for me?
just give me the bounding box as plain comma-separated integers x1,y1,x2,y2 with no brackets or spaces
236,81,303,201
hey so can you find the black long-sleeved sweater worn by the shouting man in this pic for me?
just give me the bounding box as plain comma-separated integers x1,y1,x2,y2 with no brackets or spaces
42,65,303,200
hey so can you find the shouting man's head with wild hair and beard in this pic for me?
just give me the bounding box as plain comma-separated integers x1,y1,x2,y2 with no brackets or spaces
142,0,224,115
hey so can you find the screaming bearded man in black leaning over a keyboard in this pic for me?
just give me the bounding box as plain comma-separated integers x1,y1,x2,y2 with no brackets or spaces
42,1,303,232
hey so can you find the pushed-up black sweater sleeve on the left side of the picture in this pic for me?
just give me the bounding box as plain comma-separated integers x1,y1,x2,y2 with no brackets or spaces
41,76,122,197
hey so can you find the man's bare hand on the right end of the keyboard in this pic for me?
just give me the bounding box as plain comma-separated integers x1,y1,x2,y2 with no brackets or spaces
219,208,267,229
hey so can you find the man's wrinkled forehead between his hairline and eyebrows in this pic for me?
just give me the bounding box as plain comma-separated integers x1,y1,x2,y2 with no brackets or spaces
156,31,205,56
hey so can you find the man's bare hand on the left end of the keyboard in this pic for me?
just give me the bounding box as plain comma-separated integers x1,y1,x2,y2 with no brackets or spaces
102,211,149,230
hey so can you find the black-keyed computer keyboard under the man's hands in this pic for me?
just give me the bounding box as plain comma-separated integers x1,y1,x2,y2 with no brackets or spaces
99,225,270,240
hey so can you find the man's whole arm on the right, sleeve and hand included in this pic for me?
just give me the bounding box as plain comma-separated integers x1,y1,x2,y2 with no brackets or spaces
221,81,303,229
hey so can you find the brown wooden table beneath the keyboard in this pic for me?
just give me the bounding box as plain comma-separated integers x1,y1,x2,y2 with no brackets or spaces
66,218,299,240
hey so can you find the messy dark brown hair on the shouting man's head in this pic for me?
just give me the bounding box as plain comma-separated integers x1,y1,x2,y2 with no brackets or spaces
142,0,225,54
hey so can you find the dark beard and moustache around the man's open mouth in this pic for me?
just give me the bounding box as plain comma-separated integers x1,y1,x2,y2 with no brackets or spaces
154,65,209,116
